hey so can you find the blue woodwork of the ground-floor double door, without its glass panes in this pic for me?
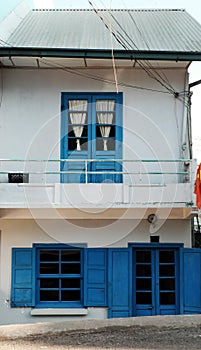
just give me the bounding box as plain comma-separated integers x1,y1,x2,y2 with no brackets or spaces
133,245,180,316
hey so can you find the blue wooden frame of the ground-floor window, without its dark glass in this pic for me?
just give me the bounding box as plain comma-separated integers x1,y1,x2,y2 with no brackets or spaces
34,244,84,308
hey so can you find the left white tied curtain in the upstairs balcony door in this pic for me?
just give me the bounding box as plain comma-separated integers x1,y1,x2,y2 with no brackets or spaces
69,100,87,151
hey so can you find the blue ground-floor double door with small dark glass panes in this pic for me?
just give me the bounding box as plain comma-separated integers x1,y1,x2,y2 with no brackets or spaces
133,248,179,316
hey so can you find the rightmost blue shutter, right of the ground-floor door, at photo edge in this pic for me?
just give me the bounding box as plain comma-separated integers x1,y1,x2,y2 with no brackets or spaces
183,248,201,314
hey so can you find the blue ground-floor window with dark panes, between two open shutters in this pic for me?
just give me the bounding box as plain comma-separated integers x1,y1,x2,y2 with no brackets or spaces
36,246,83,307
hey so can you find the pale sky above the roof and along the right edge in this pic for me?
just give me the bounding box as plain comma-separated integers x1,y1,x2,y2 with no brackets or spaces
0,0,201,162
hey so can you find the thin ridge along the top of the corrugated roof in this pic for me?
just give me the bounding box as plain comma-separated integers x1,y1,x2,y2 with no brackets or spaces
32,8,185,12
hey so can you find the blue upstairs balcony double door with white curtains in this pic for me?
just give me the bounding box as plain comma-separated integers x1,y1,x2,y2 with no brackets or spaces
61,93,122,183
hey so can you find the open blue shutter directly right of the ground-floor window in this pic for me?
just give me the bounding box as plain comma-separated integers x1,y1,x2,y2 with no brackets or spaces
84,248,107,306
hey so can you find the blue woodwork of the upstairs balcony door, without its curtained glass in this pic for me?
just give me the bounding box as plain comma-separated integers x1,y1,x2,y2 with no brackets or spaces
60,93,123,183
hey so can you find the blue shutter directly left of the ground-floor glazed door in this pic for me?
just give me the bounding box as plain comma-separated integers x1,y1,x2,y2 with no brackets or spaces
108,248,131,318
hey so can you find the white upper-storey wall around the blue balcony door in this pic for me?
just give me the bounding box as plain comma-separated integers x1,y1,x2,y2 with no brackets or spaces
0,68,186,183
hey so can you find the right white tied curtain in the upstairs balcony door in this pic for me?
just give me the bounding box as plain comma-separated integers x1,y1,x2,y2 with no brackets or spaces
96,100,115,151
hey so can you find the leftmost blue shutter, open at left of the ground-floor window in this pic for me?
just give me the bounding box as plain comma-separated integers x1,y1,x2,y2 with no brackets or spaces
11,248,35,307
